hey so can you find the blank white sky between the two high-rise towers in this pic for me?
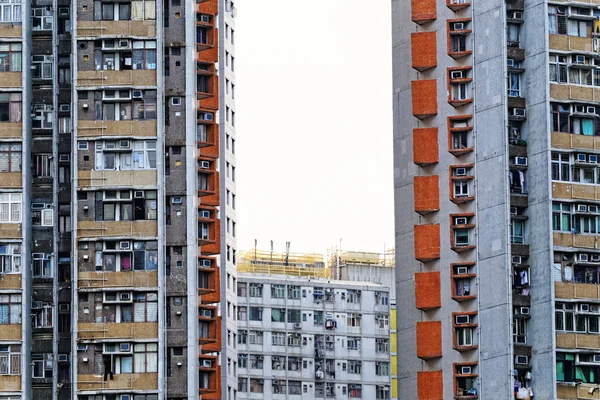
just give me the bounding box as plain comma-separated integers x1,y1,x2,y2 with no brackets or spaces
235,0,394,253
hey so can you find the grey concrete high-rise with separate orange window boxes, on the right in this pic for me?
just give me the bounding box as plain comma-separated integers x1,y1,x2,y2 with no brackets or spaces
392,0,600,400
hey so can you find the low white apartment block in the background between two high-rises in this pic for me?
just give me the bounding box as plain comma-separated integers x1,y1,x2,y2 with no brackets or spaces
234,274,391,400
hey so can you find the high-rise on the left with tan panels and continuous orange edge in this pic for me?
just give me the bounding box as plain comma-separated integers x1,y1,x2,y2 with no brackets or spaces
0,0,237,400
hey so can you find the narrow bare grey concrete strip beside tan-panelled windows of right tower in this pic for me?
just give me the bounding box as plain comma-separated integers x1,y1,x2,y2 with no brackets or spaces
522,0,556,399
